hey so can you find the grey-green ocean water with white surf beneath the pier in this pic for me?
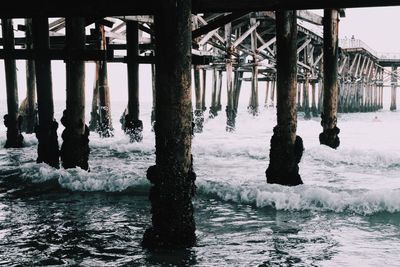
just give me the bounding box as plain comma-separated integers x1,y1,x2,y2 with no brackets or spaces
0,61,400,267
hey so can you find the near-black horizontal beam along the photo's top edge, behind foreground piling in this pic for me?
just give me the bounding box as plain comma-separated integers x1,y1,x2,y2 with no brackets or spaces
0,0,400,17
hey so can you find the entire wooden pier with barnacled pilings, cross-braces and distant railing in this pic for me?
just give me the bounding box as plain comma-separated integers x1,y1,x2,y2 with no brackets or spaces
0,0,400,248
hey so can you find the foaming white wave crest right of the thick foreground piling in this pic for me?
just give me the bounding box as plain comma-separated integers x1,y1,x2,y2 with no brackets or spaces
197,181,400,215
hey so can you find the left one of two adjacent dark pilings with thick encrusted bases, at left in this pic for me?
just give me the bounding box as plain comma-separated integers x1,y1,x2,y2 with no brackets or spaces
32,17,60,168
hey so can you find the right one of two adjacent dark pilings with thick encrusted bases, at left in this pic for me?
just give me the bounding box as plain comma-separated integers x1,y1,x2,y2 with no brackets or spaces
61,17,89,170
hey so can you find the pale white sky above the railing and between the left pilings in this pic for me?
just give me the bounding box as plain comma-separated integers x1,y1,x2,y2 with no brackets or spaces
0,7,400,105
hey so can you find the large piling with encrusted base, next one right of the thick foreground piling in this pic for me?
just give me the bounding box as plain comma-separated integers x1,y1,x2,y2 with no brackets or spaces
265,10,304,185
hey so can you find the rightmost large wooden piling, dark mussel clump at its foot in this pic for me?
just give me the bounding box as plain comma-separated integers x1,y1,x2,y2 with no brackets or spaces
319,9,340,148
